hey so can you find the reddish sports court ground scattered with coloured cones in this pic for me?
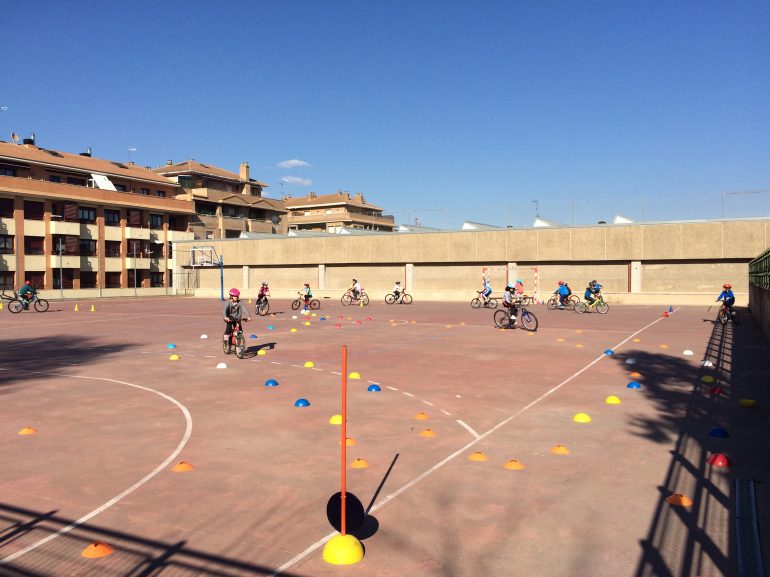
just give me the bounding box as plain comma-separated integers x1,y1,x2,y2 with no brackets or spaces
0,298,770,577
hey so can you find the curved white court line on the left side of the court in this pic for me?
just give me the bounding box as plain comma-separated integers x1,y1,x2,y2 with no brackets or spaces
0,368,192,565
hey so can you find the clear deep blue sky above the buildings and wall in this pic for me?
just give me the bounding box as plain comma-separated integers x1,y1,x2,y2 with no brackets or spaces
0,0,770,227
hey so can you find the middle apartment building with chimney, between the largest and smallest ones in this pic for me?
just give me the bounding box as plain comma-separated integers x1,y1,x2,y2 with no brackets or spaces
153,160,286,239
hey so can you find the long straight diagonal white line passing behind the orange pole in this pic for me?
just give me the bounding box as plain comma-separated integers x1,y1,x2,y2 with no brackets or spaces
267,309,664,577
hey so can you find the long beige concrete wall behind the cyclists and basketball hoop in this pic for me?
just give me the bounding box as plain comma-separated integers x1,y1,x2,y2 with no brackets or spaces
174,218,770,305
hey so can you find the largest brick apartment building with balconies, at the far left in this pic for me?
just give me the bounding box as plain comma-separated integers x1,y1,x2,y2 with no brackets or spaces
0,135,195,298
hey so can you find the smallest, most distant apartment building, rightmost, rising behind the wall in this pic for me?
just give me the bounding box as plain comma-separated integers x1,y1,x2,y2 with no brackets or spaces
284,191,396,232
